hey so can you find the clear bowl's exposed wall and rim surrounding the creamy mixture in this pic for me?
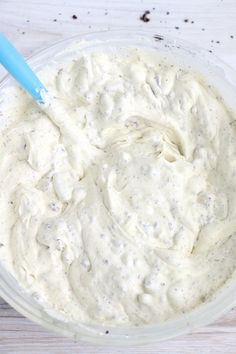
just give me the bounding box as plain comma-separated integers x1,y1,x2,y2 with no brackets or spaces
0,30,236,346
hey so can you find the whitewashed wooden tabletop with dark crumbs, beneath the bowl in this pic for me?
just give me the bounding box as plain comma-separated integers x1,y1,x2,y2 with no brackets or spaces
0,0,236,354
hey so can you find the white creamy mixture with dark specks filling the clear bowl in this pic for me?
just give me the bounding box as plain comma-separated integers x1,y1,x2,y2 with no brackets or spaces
0,49,236,325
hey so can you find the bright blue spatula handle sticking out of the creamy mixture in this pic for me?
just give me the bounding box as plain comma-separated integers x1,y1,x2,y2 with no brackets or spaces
0,33,47,104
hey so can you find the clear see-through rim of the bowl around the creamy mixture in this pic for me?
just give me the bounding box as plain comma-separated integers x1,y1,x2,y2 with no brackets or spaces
0,30,236,346
